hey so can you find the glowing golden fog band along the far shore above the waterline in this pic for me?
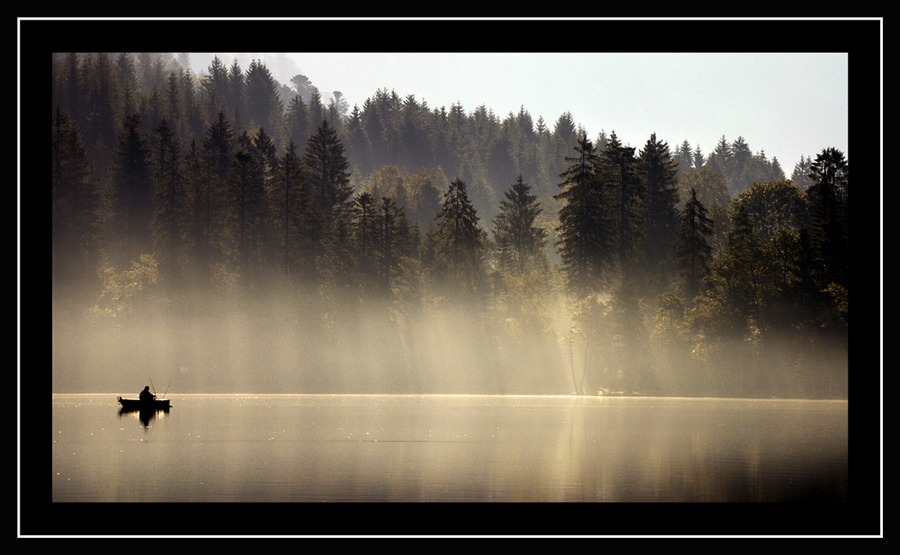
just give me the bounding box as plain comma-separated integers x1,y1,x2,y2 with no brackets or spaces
52,276,848,398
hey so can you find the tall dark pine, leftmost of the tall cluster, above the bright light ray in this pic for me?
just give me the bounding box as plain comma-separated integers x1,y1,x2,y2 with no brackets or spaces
554,134,615,296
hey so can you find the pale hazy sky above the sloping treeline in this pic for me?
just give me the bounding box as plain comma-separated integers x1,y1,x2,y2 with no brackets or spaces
191,52,849,169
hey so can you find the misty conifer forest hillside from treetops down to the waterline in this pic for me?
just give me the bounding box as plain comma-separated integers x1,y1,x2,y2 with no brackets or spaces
51,52,849,399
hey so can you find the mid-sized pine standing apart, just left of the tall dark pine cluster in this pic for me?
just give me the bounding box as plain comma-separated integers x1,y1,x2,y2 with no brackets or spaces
494,175,547,274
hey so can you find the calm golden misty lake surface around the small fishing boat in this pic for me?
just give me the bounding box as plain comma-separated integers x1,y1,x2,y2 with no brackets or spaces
52,394,849,502
